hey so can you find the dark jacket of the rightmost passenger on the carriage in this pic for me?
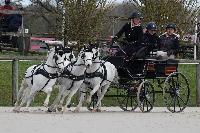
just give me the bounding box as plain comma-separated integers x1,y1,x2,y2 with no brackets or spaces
159,34,179,55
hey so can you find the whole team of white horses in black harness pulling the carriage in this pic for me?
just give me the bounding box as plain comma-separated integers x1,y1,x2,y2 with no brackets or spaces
13,44,118,112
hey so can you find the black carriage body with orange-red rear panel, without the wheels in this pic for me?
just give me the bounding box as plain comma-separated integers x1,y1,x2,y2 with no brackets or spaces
105,56,178,80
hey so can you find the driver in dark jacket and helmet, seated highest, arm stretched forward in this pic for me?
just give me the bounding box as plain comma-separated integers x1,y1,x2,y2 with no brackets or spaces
112,12,143,57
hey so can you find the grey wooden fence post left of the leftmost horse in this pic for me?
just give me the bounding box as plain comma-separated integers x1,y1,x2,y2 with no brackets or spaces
12,58,18,105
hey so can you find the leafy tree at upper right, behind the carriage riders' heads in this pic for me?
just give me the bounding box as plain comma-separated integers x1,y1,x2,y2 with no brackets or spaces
126,0,199,35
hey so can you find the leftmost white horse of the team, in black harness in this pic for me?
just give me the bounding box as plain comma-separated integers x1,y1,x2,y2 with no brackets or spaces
13,46,73,112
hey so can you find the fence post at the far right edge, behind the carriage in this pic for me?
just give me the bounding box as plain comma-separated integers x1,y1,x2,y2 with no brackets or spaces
196,63,200,107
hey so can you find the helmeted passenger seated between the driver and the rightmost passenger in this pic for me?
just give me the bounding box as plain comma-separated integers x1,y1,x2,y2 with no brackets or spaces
141,22,160,57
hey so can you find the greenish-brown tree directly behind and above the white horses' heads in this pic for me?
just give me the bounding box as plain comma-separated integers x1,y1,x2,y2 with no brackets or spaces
64,0,111,47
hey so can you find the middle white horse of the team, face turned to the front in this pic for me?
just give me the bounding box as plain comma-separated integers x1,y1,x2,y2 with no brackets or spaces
48,46,94,112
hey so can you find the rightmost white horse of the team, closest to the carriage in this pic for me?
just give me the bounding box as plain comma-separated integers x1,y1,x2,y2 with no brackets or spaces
74,47,118,112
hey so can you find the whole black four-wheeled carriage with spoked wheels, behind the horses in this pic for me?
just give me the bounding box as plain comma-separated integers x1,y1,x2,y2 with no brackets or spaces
88,42,190,112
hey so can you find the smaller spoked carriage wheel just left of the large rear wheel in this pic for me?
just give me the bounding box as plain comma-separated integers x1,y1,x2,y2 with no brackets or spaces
137,80,155,112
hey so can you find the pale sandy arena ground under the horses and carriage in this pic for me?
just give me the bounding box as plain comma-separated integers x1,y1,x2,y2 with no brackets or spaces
0,107,200,133
